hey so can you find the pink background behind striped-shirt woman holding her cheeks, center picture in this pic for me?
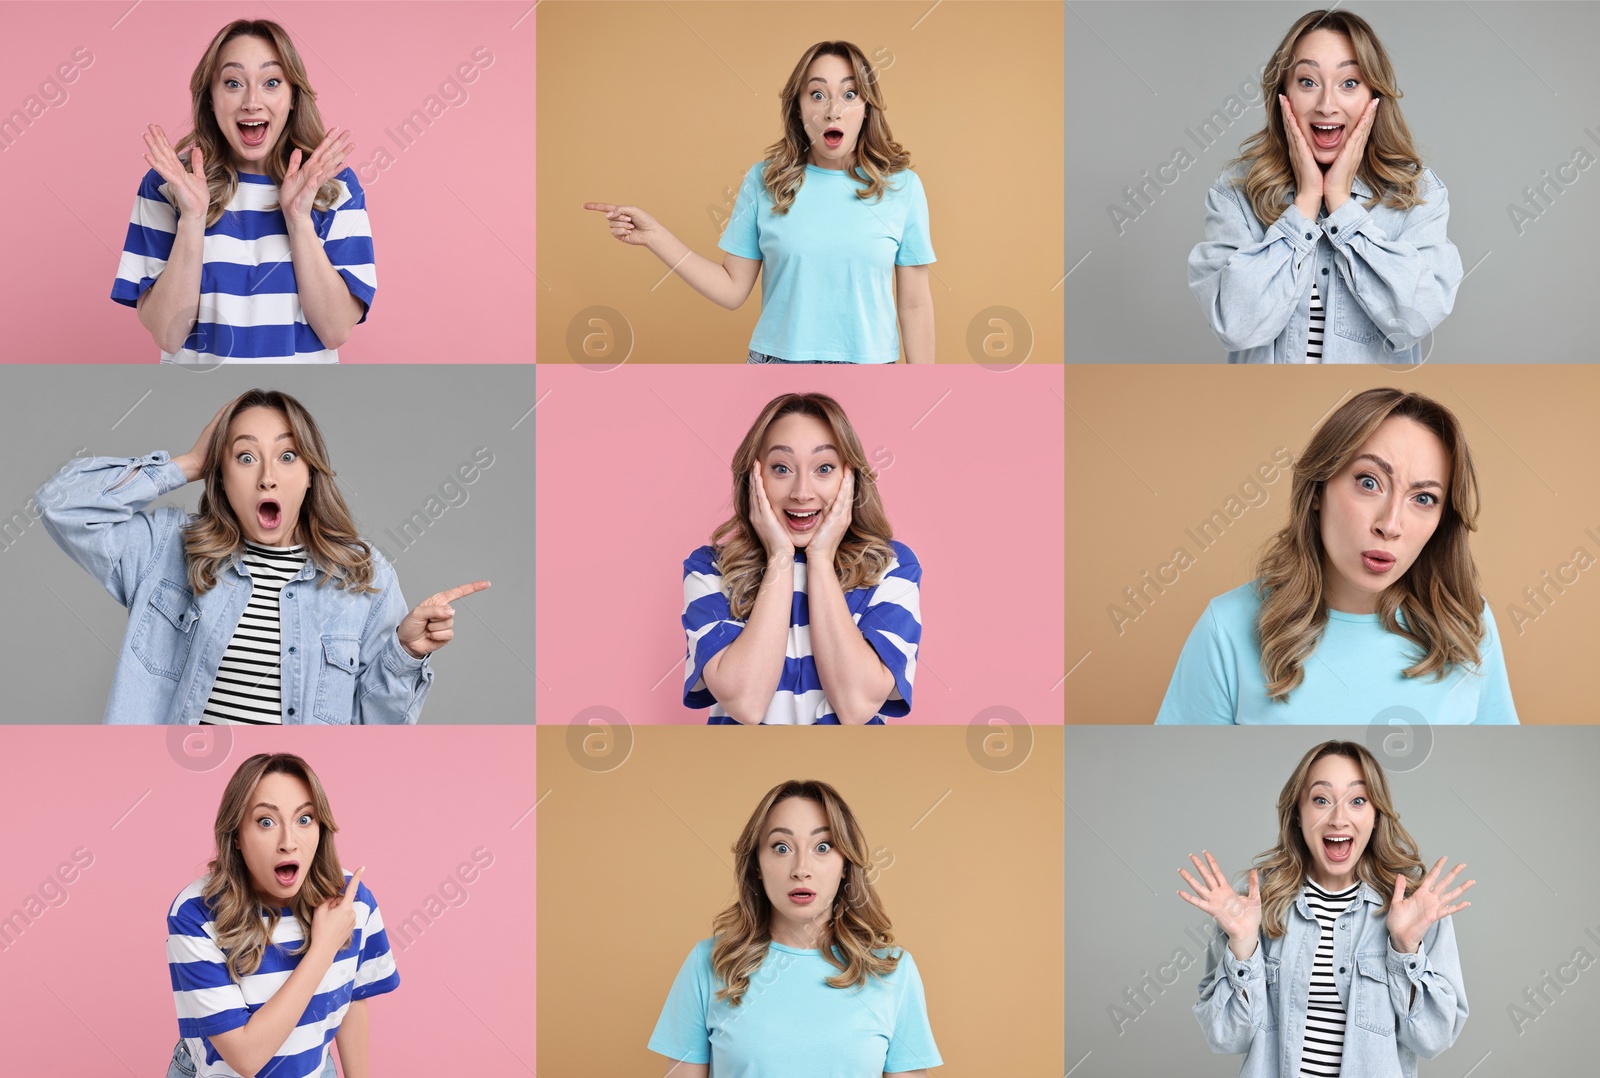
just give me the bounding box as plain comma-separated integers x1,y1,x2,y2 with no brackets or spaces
534,365,1066,725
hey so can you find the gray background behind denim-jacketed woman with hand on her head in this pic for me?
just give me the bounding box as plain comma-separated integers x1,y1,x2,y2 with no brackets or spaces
0,365,534,723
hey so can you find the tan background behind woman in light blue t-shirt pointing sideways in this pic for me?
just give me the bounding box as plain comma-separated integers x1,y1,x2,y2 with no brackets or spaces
538,0,1066,363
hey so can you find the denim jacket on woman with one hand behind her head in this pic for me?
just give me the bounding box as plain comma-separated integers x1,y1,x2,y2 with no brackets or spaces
37,451,434,726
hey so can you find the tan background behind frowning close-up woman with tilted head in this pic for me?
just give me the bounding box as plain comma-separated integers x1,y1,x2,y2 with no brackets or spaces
1064,366,1600,723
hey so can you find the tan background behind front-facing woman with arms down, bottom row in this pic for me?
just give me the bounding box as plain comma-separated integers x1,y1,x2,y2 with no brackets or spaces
538,726,1064,1078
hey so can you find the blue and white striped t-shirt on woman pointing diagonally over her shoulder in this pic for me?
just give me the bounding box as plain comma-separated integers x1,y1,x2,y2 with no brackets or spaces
166,873,400,1078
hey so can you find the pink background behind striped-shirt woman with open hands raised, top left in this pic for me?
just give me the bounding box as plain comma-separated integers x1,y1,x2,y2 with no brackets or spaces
0,0,538,363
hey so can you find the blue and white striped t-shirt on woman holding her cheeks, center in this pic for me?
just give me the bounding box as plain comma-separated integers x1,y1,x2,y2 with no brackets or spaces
683,541,922,726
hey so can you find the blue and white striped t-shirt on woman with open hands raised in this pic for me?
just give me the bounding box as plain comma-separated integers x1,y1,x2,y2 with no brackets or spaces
110,168,378,363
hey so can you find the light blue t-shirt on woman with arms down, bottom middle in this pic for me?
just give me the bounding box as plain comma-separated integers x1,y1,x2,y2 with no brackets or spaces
650,939,944,1078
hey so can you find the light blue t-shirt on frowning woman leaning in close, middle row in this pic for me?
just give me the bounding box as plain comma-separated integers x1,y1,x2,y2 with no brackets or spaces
1155,582,1517,726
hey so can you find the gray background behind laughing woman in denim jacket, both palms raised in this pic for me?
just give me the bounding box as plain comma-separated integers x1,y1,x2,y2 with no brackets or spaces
1066,726,1600,1078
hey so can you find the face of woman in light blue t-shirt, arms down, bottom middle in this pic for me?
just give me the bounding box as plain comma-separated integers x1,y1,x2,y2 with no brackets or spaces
757,797,845,947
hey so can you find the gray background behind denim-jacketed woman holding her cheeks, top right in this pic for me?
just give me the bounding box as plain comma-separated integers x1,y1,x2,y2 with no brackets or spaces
1064,0,1600,363
